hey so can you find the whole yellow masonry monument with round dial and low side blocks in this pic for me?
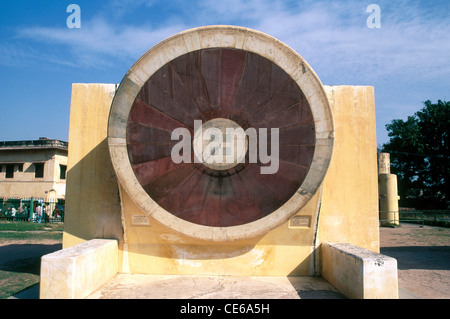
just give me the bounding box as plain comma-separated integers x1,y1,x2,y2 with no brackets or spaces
47,26,398,298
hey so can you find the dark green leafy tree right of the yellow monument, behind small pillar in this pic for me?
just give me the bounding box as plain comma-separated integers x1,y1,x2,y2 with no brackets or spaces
383,100,450,209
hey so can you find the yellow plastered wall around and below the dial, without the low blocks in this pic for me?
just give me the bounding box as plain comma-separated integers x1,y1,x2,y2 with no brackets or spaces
63,84,379,276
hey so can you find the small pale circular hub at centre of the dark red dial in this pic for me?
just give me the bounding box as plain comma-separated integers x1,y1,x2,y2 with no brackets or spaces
192,118,248,171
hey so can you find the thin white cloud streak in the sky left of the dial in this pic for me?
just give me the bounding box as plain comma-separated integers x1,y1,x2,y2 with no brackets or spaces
17,18,185,68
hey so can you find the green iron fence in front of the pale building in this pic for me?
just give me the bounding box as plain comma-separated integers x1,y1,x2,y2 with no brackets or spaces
0,198,65,223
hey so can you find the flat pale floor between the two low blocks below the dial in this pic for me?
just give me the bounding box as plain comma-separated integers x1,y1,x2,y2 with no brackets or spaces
87,274,345,299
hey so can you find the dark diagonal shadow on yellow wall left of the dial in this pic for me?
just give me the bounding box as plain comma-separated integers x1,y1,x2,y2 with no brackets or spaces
63,139,123,248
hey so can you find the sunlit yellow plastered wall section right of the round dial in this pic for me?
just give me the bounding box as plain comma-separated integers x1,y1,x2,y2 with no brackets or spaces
318,86,379,252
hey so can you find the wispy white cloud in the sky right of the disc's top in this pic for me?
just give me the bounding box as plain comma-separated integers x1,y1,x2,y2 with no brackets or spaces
232,1,450,81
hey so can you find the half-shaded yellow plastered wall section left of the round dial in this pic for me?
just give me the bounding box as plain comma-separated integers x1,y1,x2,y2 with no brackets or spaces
63,84,123,248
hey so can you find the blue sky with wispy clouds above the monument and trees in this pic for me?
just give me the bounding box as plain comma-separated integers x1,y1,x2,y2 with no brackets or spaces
0,0,450,144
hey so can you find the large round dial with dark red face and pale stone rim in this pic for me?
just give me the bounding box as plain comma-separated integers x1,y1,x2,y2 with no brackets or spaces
108,26,334,241
